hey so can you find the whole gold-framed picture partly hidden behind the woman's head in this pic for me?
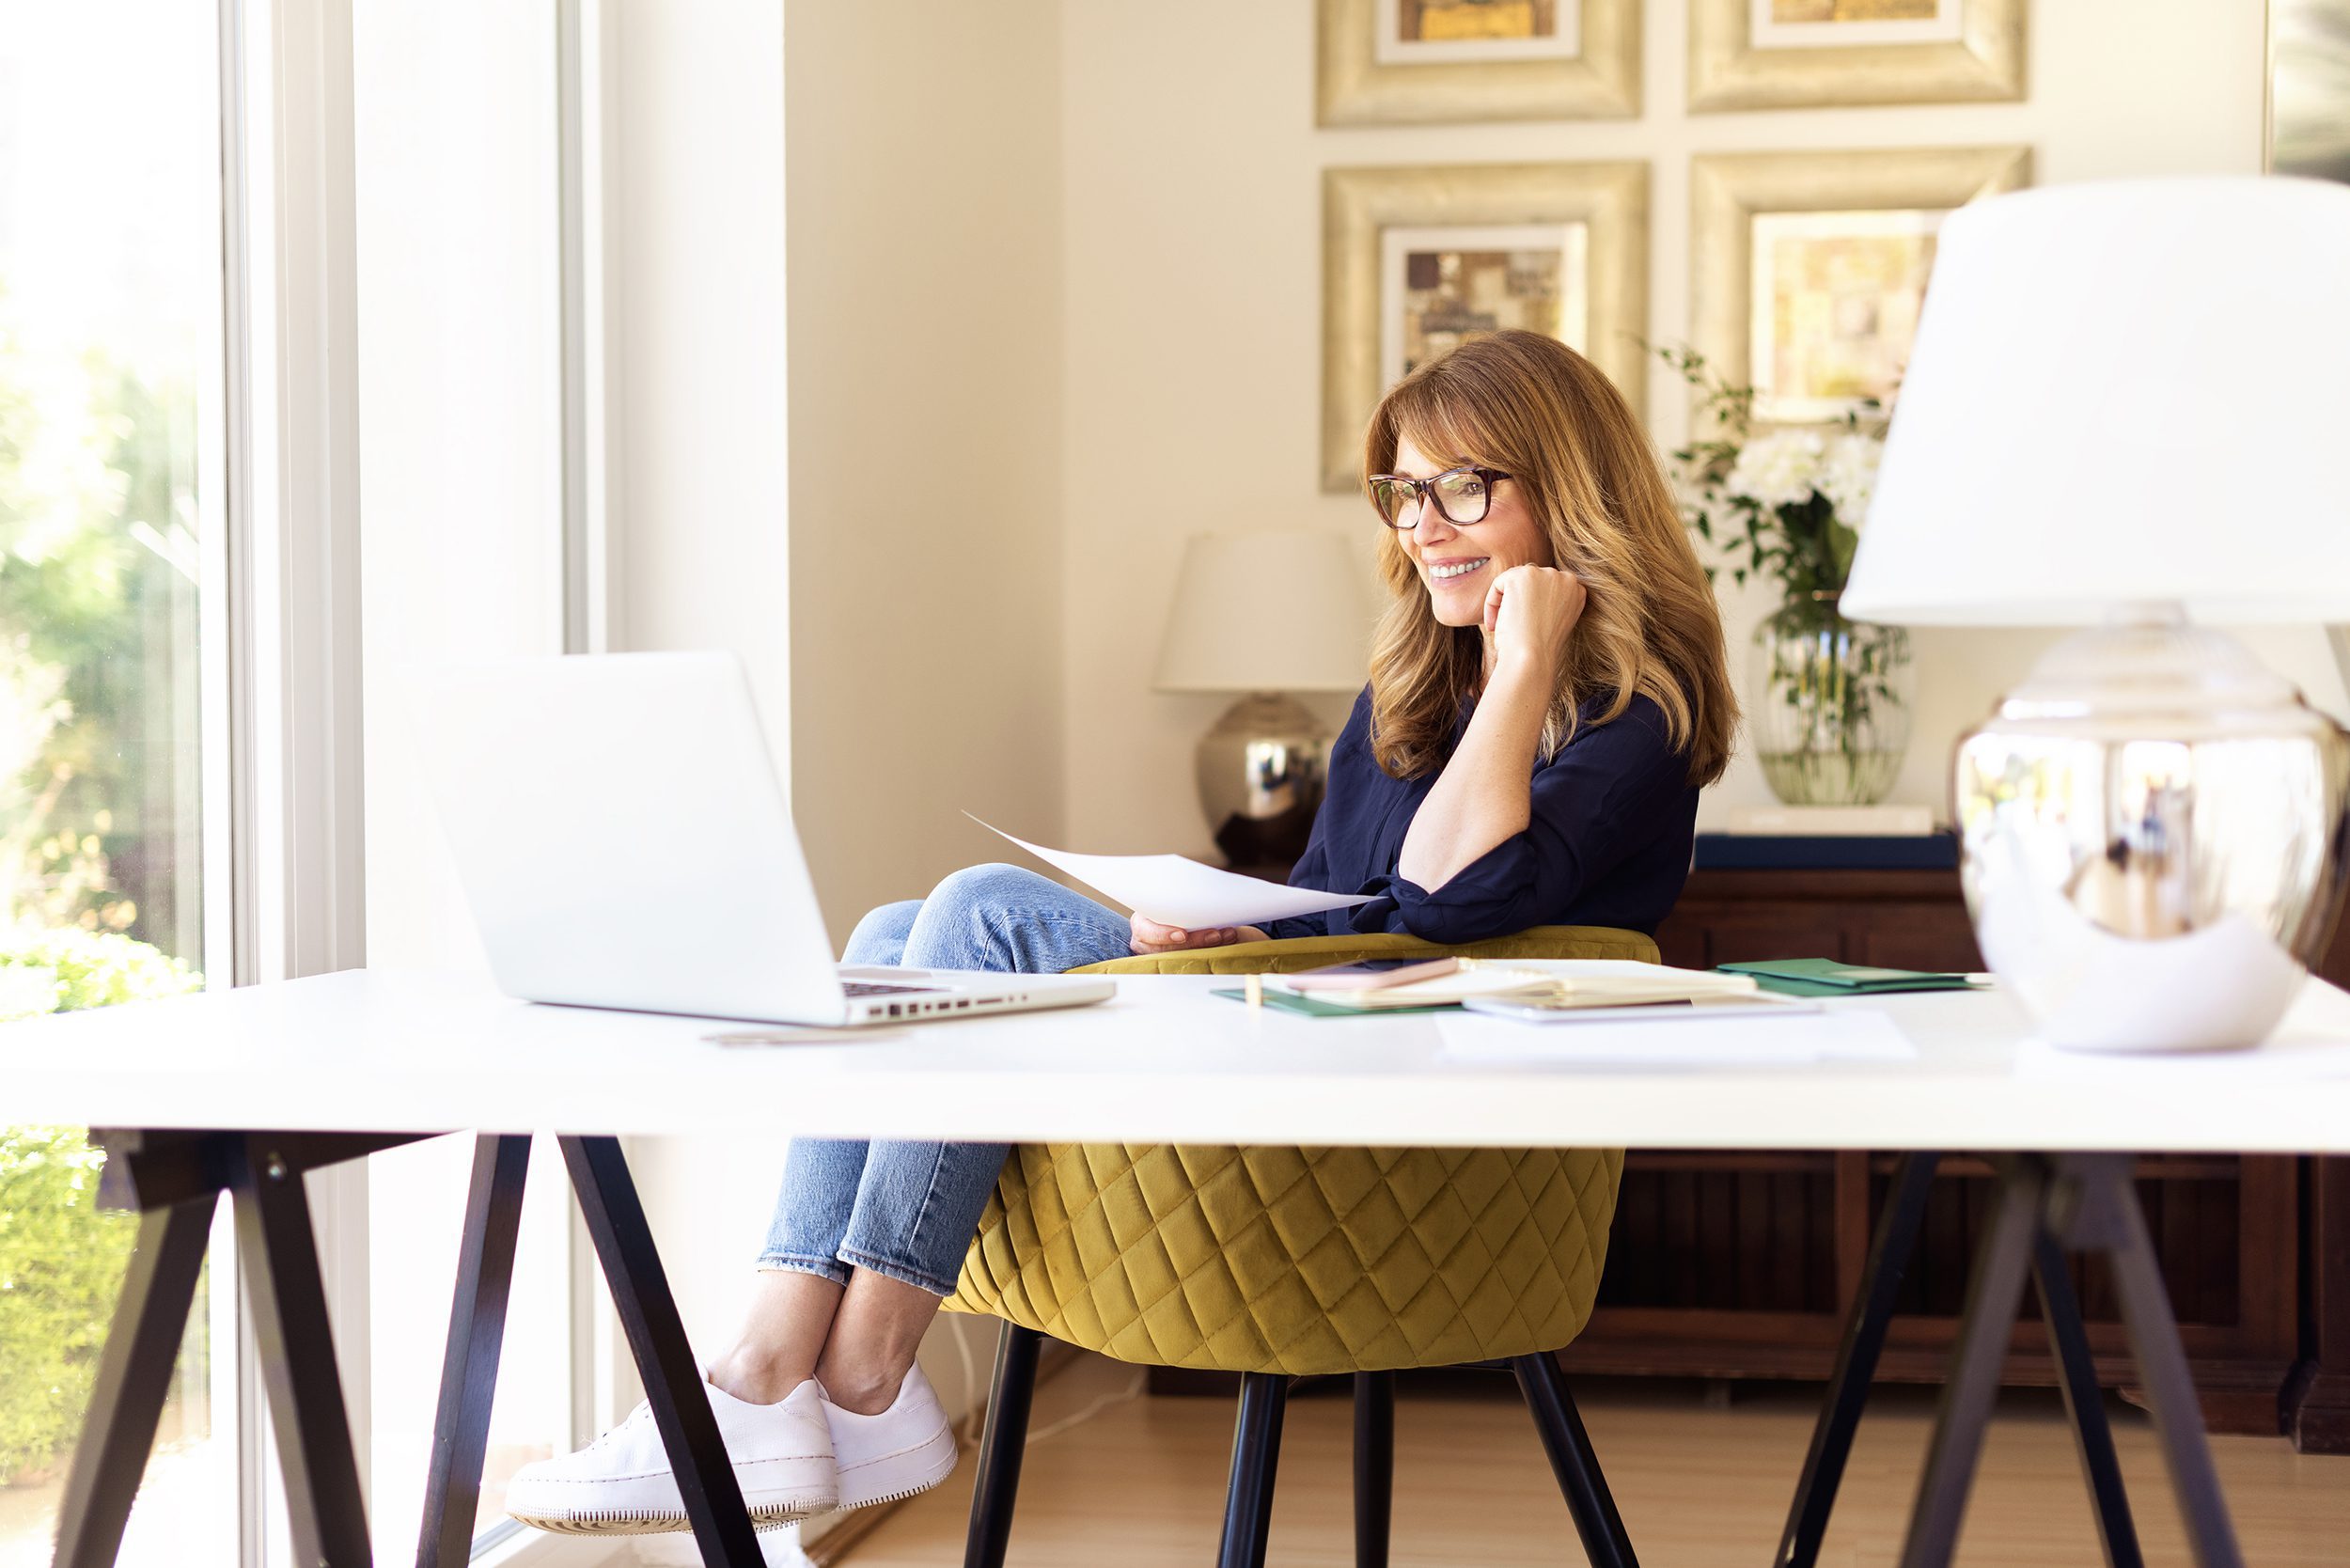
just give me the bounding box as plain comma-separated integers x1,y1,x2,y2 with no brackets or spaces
1324,163,1648,492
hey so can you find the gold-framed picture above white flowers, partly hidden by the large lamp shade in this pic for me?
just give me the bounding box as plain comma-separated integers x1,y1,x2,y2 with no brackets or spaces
1690,146,2030,426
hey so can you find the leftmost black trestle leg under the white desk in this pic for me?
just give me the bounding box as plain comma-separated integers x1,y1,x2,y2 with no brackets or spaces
55,1192,219,1568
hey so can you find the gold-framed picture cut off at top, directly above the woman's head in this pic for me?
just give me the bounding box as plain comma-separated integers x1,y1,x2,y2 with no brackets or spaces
1319,0,1640,125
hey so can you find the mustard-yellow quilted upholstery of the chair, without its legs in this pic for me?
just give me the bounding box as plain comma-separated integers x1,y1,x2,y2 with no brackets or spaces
948,926,1657,1375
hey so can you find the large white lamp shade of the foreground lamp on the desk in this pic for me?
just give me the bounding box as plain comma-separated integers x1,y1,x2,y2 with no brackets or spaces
1842,177,2350,625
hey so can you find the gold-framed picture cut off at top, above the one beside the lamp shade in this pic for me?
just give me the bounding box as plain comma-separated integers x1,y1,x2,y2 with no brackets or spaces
1690,0,2026,113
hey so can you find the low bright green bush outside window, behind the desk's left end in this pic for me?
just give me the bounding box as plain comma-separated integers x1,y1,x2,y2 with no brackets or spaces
0,929,205,1485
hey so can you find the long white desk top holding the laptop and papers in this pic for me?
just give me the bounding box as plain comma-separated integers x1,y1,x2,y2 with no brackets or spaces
0,971,2350,1154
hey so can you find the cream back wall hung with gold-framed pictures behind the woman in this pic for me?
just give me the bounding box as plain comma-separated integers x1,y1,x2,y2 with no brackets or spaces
1062,0,2343,854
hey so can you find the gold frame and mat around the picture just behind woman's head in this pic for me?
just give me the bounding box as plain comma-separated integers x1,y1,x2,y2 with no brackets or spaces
1324,160,1648,492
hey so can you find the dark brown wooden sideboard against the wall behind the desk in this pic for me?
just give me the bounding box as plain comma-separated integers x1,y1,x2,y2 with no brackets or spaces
1563,870,2350,1452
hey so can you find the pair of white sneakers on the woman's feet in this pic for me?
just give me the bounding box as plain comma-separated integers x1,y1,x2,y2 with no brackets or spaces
506,1380,841,1535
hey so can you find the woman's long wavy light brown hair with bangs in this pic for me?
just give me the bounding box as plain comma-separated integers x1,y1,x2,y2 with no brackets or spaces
1363,332,1739,785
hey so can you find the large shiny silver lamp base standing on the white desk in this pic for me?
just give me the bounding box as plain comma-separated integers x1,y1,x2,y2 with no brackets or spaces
1953,604,2350,1051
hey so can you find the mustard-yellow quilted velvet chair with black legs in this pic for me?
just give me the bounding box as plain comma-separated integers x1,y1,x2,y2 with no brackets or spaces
948,926,1657,1568
